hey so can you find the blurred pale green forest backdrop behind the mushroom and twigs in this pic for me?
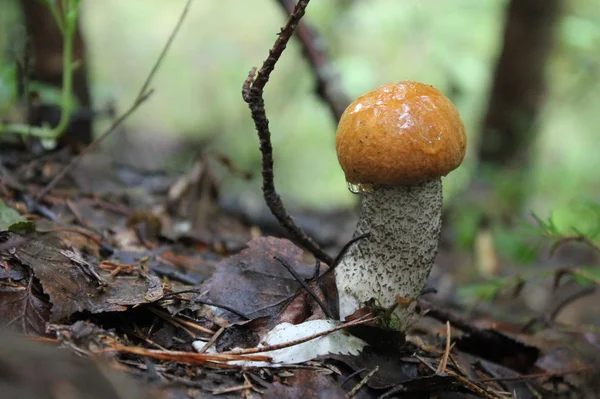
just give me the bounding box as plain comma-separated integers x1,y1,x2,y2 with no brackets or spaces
0,0,600,231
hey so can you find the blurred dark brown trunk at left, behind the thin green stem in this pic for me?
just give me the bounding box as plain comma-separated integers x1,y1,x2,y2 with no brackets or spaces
20,0,92,147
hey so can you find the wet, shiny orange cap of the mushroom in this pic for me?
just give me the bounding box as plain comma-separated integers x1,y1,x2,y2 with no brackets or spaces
335,81,467,186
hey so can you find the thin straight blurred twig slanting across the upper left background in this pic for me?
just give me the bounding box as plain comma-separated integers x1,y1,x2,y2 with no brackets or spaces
36,0,192,202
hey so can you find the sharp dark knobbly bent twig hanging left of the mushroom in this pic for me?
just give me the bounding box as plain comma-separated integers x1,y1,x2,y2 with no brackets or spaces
242,0,333,265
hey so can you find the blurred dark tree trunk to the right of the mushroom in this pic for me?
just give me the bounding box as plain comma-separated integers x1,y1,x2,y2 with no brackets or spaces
479,0,562,168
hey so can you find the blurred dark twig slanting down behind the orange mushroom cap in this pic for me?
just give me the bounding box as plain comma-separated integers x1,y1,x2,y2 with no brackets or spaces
277,0,350,121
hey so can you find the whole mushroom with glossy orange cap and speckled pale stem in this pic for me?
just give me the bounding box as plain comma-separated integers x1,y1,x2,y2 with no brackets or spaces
335,81,467,331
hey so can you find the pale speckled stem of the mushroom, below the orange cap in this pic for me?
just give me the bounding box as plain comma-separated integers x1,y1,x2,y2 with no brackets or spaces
335,178,442,330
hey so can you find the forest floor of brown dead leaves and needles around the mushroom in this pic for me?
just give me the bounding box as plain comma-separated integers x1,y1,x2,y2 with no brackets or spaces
0,145,600,399
